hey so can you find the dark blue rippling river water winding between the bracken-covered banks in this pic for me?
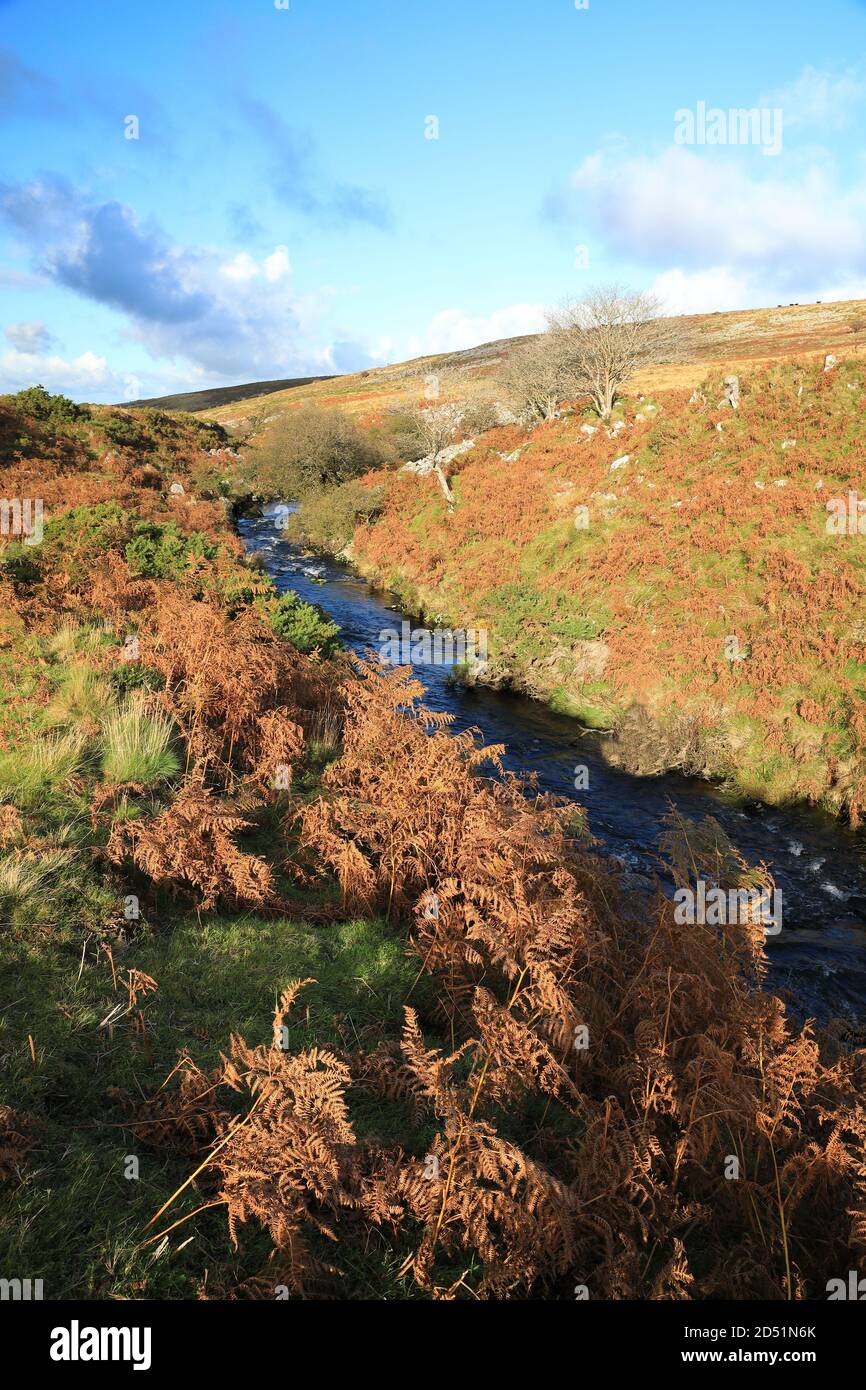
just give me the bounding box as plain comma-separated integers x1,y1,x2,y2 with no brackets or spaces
238,506,866,1023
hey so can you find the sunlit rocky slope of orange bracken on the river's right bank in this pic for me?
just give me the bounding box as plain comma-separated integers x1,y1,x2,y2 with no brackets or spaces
286,361,866,824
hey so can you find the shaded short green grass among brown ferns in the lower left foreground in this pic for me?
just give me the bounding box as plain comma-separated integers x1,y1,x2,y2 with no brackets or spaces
0,912,432,1298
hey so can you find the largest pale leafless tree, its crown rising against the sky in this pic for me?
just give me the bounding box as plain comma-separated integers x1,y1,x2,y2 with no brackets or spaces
548,285,683,420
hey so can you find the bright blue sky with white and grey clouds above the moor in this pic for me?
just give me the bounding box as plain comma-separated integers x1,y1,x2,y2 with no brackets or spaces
0,0,866,402
